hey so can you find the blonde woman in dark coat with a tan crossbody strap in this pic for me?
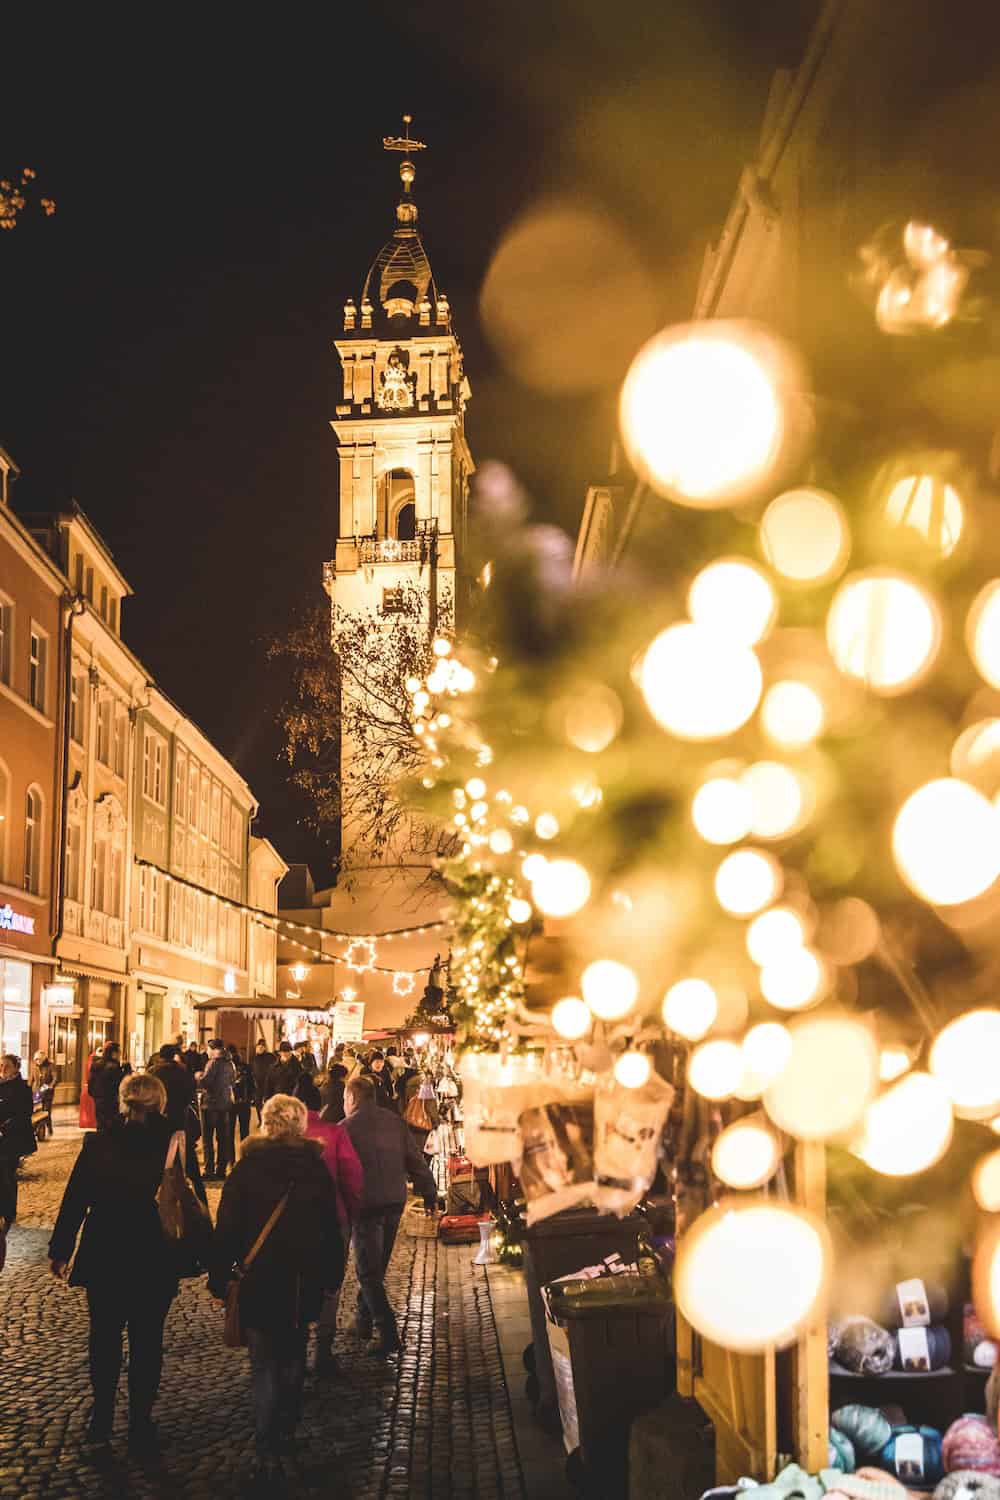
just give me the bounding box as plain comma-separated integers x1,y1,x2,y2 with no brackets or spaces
208,1094,345,1493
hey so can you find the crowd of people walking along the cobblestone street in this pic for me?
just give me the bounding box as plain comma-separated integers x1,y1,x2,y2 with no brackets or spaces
0,1038,449,1496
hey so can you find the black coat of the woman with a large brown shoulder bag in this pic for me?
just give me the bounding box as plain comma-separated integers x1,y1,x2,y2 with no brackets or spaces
48,1115,177,1296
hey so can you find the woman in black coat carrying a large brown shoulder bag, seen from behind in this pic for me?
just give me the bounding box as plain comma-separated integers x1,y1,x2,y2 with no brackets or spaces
48,1073,177,1452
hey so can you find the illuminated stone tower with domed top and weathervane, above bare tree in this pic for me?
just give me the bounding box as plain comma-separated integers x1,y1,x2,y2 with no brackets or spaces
324,116,474,870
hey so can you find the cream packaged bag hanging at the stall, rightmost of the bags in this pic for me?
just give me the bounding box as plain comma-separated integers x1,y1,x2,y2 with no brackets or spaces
594,1073,675,1218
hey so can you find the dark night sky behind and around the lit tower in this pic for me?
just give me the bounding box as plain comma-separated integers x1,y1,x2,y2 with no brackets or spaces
0,0,816,875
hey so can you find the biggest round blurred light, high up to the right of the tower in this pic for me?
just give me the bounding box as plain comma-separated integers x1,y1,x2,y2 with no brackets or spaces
619,323,786,509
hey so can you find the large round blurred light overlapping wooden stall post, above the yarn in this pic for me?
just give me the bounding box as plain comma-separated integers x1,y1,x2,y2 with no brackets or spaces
673,1200,831,1353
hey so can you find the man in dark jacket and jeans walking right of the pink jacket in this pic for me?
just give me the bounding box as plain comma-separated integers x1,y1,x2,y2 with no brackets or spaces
343,1076,438,1355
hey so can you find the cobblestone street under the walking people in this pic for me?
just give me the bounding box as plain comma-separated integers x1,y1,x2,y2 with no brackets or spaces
0,1128,547,1500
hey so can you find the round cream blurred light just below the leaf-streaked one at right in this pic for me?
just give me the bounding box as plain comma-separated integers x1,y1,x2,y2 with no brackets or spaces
826,572,942,693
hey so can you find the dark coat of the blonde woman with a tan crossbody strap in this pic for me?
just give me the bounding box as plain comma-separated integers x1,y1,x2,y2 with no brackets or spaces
208,1136,345,1331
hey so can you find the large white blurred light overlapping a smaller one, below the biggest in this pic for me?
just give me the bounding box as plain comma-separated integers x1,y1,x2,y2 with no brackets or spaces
640,624,763,740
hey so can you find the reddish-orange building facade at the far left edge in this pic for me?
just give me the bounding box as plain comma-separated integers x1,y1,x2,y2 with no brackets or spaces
0,450,69,1058
